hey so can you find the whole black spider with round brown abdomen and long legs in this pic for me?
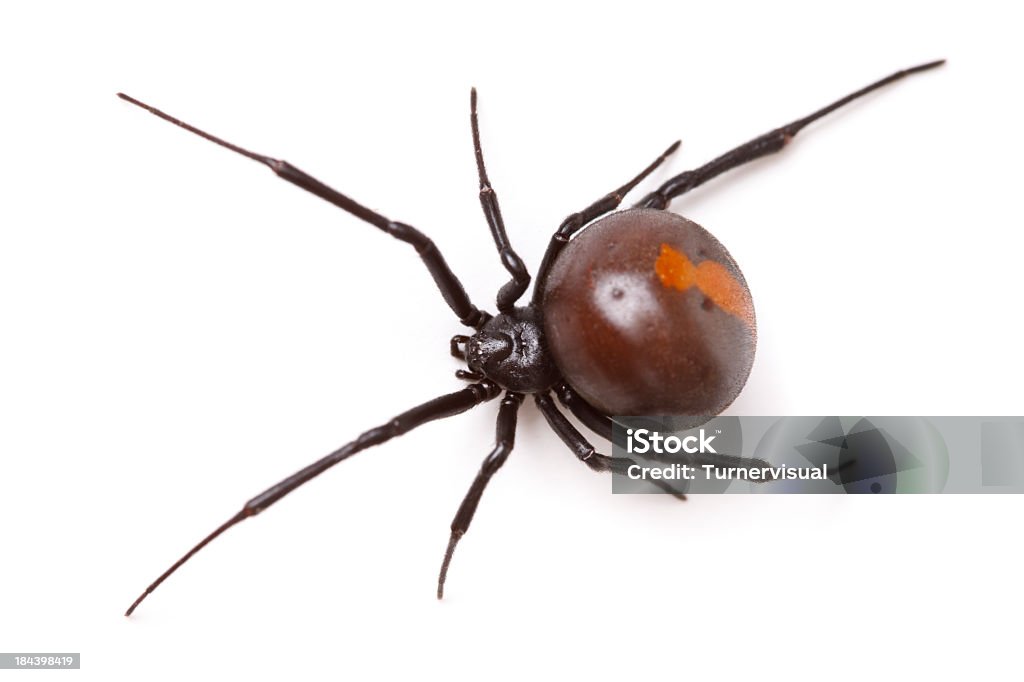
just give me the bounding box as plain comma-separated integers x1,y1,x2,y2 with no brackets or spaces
118,59,944,615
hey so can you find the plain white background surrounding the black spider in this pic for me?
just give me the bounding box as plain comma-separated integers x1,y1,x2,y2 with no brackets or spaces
0,1,1024,680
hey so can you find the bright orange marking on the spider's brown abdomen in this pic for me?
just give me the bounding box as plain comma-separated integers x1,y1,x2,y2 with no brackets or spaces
654,244,754,326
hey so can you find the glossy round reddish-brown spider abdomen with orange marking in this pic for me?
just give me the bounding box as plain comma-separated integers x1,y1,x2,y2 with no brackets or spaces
542,209,757,416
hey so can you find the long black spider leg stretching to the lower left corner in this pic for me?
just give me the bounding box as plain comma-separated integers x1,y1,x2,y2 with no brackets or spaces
125,381,501,615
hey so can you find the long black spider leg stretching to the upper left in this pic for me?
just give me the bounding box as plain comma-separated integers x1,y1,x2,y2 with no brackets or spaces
118,92,490,329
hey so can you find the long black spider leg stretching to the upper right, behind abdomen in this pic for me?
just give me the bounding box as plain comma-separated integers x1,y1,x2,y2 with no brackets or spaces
637,59,945,209
